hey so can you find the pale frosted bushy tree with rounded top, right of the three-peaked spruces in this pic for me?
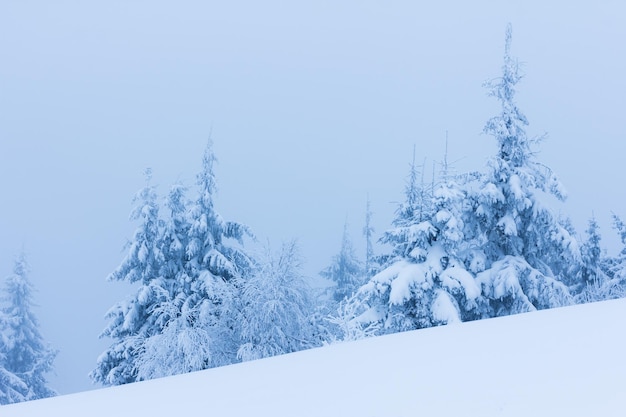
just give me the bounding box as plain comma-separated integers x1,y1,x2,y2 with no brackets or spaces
237,241,316,361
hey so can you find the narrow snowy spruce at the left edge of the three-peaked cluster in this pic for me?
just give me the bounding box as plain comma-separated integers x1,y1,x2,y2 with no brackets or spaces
90,169,166,385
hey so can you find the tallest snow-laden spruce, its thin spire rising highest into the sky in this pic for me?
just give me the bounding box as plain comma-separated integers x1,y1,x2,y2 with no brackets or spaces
470,25,580,316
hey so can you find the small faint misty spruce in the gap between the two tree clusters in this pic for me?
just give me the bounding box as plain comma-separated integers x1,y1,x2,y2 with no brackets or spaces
320,222,364,302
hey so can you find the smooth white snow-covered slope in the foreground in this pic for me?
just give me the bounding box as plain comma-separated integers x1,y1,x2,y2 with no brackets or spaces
0,300,626,417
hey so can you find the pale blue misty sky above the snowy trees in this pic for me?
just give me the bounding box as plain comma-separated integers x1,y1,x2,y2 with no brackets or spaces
0,1,626,393
